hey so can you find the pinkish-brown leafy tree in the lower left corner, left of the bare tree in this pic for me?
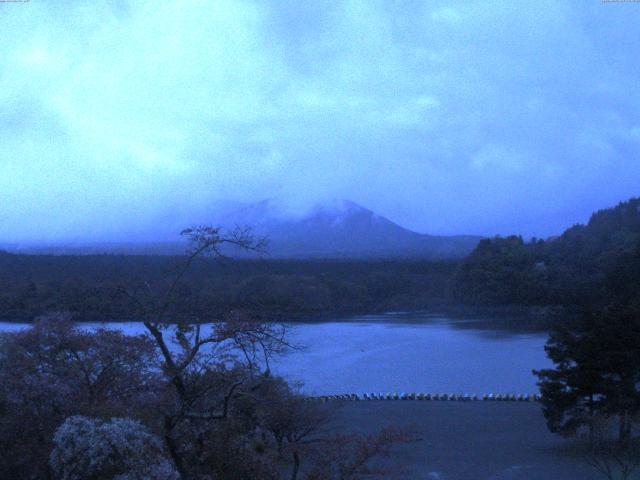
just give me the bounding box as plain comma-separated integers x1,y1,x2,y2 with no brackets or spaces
0,315,161,478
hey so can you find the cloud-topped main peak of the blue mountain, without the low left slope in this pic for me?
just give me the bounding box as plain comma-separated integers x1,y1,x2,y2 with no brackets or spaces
214,200,481,259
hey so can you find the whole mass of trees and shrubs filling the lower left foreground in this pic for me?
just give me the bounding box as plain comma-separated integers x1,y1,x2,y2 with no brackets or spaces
0,318,410,480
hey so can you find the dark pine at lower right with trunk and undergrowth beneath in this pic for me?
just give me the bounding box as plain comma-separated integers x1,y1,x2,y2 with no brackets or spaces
534,300,640,480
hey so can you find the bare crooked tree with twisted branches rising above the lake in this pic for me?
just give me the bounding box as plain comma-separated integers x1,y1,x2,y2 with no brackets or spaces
118,226,289,478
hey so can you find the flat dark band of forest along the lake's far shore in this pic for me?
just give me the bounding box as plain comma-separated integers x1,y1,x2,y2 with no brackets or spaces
0,252,458,321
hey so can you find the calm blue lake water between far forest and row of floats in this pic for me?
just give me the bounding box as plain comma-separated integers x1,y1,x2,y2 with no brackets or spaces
0,313,551,395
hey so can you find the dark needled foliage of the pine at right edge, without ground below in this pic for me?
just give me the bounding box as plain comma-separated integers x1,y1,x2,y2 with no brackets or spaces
535,304,640,443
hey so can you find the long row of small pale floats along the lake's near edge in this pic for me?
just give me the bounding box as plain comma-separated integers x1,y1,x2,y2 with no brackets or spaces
307,393,540,402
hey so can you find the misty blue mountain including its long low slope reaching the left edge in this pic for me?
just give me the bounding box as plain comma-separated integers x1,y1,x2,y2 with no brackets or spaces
5,199,481,259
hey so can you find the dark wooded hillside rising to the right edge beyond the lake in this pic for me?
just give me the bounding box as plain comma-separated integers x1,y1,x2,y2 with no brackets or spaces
453,199,640,307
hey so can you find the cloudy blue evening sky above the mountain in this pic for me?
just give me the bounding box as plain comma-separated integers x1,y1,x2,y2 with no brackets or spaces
0,0,640,242
